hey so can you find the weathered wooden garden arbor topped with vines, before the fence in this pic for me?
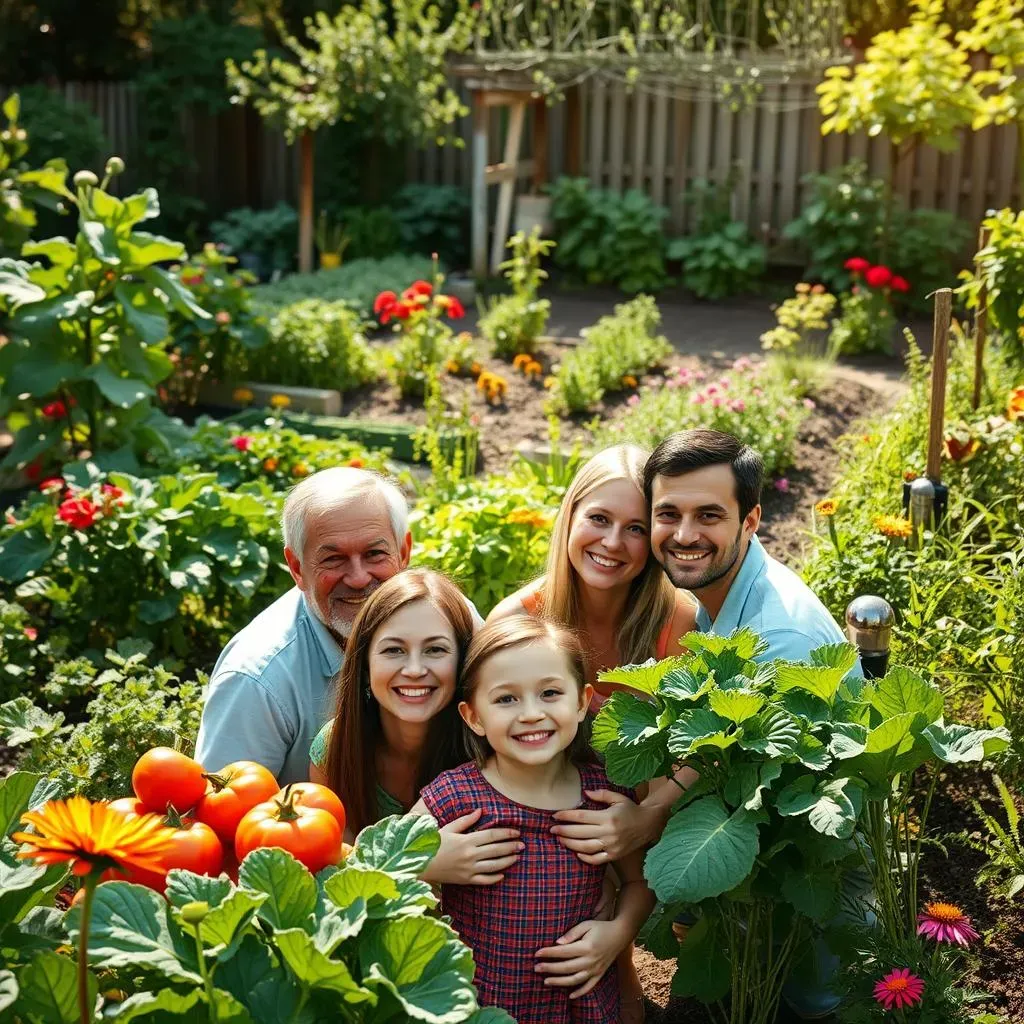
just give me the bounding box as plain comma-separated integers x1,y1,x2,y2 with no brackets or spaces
464,0,845,276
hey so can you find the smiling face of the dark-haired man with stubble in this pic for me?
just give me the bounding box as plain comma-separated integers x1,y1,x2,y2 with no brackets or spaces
650,464,761,605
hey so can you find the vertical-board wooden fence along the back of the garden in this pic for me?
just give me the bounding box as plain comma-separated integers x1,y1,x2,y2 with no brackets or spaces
0,80,1020,237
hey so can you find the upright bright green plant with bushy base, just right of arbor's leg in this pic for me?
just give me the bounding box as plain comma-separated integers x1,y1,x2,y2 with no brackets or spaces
478,227,555,359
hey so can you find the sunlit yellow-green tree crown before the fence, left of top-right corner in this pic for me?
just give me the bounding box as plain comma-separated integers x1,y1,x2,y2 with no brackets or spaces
817,0,980,151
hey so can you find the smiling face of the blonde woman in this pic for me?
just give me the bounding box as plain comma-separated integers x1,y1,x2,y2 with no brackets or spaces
568,480,650,590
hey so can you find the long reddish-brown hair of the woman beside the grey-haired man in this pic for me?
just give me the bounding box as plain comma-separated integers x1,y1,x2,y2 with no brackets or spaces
325,569,473,833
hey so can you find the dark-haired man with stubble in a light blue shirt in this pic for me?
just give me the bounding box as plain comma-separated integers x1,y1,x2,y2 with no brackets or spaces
644,430,860,675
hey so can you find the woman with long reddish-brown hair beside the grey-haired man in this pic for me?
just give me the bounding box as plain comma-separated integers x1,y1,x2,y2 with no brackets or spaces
309,569,521,885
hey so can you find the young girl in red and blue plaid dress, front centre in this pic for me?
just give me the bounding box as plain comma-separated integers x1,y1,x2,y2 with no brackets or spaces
405,615,654,1024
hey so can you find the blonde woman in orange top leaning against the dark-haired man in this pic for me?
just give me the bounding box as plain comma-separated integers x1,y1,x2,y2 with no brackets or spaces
487,444,697,1024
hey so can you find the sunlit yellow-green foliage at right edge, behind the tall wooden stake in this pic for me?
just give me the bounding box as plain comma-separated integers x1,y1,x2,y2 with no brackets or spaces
958,209,1024,357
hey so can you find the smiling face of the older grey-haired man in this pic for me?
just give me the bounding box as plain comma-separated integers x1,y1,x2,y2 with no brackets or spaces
285,495,412,642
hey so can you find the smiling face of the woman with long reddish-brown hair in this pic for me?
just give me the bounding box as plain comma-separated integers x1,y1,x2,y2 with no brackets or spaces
369,600,459,723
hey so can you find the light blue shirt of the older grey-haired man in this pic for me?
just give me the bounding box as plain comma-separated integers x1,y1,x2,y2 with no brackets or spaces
196,587,343,785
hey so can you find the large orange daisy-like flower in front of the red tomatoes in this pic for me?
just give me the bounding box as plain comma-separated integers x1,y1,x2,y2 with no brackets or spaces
11,797,172,876
